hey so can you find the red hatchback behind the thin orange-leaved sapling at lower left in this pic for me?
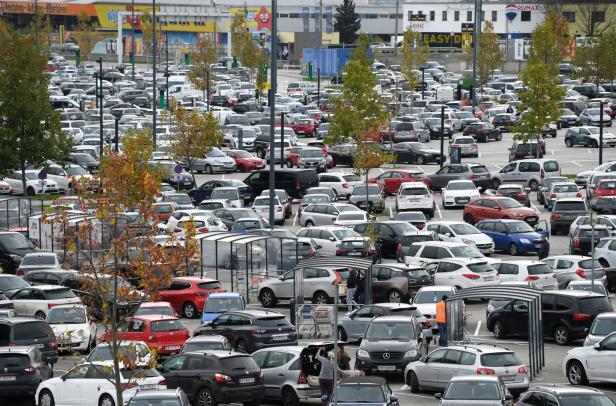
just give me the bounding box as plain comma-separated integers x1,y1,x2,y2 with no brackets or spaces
100,314,190,355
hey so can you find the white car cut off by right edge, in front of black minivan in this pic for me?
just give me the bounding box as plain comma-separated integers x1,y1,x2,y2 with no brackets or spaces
562,333,616,385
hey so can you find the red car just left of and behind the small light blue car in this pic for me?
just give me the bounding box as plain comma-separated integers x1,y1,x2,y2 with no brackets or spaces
160,276,226,319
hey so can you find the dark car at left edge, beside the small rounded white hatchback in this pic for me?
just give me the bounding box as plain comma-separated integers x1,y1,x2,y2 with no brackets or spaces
0,317,58,364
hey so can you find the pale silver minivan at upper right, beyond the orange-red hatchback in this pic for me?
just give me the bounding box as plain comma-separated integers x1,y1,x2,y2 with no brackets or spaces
492,159,560,191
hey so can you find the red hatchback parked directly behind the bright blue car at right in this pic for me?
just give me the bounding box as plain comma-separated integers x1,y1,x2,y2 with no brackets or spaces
463,196,539,226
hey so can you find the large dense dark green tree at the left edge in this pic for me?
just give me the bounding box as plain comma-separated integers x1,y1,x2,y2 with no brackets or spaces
0,27,71,193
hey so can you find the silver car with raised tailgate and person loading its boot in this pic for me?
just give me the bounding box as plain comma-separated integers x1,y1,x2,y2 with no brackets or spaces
252,343,334,406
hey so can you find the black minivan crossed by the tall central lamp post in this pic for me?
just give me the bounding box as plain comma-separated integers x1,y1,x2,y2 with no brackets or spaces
244,169,319,199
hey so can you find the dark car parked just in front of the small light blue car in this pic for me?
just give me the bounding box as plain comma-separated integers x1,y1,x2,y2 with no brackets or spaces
193,310,297,353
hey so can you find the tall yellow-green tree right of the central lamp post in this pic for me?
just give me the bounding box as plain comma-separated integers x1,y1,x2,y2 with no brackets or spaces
325,34,392,213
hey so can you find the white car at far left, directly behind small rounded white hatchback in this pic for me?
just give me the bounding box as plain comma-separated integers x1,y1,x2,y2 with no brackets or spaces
11,285,81,319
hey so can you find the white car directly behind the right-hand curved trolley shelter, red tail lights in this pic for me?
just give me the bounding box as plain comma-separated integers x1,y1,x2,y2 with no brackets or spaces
426,258,500,289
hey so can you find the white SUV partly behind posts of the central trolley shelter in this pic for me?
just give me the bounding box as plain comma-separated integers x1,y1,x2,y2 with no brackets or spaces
257,267,346,307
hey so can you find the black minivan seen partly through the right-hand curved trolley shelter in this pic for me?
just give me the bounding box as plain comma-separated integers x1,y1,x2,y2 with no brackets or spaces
487,290,612,345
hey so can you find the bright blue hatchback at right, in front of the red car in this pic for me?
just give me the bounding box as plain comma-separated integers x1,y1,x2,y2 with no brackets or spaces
475,219,550,255
